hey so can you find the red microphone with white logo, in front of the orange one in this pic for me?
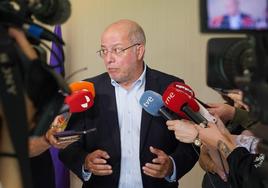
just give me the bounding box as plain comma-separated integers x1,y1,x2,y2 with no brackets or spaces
59,91,94,114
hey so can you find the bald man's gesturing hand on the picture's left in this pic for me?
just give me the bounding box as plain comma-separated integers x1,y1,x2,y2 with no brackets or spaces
85,150,113,176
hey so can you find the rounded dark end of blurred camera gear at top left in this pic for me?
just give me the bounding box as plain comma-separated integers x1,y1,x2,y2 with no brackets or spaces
28,0,71,25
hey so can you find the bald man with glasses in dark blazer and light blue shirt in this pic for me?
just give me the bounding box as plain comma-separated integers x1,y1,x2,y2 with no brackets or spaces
60,20,198,188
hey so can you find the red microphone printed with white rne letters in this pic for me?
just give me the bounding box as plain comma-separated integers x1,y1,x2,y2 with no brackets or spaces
162,87,208,125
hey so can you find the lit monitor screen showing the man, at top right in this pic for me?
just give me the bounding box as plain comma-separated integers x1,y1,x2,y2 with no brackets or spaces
200,0,268,34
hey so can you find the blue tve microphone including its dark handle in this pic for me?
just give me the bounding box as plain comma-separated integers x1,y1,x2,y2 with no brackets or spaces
139,90,178,120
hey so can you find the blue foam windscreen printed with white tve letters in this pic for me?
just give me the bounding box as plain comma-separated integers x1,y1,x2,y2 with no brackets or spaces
139,90,164,116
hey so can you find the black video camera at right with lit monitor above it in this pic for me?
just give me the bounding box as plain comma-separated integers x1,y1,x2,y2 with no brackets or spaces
200,0,268,124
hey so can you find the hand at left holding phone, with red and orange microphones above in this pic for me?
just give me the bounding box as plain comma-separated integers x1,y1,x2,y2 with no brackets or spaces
46,81,95,144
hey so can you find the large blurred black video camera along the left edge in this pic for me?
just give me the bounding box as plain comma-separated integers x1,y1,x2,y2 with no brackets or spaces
0,0,71,187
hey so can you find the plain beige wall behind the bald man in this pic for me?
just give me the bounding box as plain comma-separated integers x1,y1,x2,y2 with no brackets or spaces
63,0,230,188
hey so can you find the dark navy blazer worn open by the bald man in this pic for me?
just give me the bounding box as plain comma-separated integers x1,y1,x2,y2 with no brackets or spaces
59,68,198,188
